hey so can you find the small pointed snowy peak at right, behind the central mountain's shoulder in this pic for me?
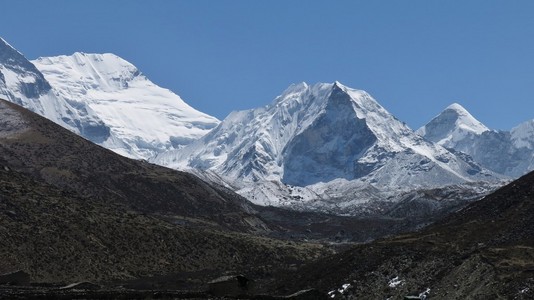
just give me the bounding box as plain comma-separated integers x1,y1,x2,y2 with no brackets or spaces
417,103,489,148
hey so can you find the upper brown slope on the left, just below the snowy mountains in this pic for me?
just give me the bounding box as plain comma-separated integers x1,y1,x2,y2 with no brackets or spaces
0,98,266,231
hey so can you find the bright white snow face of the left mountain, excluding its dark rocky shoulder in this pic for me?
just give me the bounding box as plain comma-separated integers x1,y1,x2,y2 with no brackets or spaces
33,52,219,159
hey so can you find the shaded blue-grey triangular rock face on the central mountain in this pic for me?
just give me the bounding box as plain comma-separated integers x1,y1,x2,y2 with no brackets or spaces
282,86,377,186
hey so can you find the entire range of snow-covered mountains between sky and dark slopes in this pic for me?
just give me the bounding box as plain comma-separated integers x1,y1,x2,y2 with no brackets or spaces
0,36,534,214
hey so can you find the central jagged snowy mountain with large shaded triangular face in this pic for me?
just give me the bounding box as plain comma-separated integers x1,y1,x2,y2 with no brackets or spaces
154,82,501,211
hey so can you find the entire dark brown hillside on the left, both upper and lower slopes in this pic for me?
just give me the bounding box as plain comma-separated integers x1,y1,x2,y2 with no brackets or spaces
0,101,327,288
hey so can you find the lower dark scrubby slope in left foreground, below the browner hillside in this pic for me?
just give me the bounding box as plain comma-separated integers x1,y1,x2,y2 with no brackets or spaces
0,170,323,282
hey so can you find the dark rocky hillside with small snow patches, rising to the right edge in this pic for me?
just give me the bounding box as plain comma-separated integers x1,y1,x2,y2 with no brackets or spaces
272,173,534,299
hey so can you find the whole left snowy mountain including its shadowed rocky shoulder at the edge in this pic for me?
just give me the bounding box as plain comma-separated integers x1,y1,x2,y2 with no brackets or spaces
0,35,219,159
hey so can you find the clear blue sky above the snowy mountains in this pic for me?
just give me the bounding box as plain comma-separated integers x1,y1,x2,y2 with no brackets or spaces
0,0,534,129
